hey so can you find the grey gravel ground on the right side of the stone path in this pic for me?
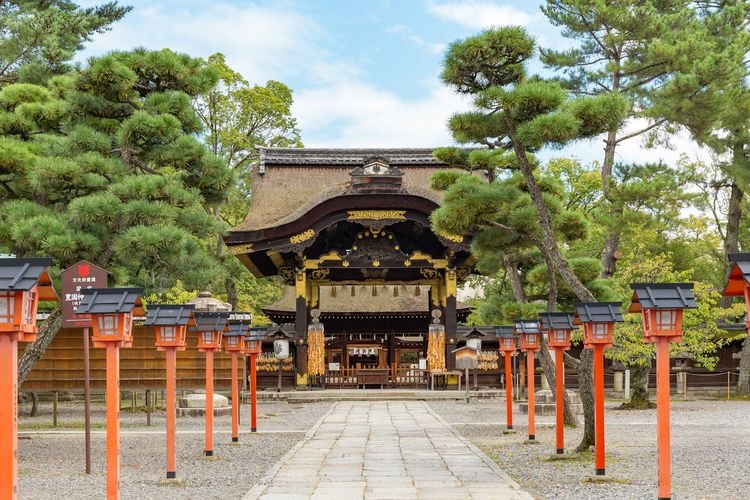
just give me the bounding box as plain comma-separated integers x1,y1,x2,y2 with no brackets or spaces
429,399,750,500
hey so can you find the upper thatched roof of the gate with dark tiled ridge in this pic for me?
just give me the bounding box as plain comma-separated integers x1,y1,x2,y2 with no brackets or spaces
234,148,456,231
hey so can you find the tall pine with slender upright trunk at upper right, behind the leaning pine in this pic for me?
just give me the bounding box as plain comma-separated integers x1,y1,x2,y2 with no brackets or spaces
542,0,747,277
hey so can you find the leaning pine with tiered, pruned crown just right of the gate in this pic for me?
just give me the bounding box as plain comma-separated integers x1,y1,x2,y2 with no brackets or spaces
433,27,627,449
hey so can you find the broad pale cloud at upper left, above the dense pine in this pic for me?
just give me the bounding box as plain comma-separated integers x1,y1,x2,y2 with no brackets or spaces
78,1,360,83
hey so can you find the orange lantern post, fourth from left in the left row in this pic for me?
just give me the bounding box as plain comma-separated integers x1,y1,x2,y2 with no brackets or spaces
193,311,229,457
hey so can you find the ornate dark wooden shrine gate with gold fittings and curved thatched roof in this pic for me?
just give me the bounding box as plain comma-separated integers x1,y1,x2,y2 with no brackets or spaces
224,148,496,387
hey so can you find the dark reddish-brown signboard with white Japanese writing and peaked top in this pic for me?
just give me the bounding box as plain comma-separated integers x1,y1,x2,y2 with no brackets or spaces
60,260,109,328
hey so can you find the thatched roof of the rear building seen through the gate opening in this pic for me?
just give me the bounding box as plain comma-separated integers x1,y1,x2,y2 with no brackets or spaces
263,285,470,314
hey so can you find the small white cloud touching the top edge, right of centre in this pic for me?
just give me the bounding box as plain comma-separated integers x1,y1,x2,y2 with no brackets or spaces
426,0,532,28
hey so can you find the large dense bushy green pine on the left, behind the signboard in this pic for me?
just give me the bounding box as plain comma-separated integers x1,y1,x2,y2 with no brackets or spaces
0,49,233,380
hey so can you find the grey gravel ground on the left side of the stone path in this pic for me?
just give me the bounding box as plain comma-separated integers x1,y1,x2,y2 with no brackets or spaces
18,401,331,499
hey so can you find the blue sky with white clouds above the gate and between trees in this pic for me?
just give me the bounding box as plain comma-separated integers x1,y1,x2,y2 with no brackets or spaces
79,0,700,166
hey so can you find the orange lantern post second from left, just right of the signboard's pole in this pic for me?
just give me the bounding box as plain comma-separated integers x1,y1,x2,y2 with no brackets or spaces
76,288,143,499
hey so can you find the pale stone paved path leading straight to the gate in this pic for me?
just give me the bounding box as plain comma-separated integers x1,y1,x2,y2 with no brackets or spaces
245,401,532,500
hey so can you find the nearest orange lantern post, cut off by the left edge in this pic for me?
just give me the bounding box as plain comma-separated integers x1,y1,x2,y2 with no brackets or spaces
0,258,57,499
